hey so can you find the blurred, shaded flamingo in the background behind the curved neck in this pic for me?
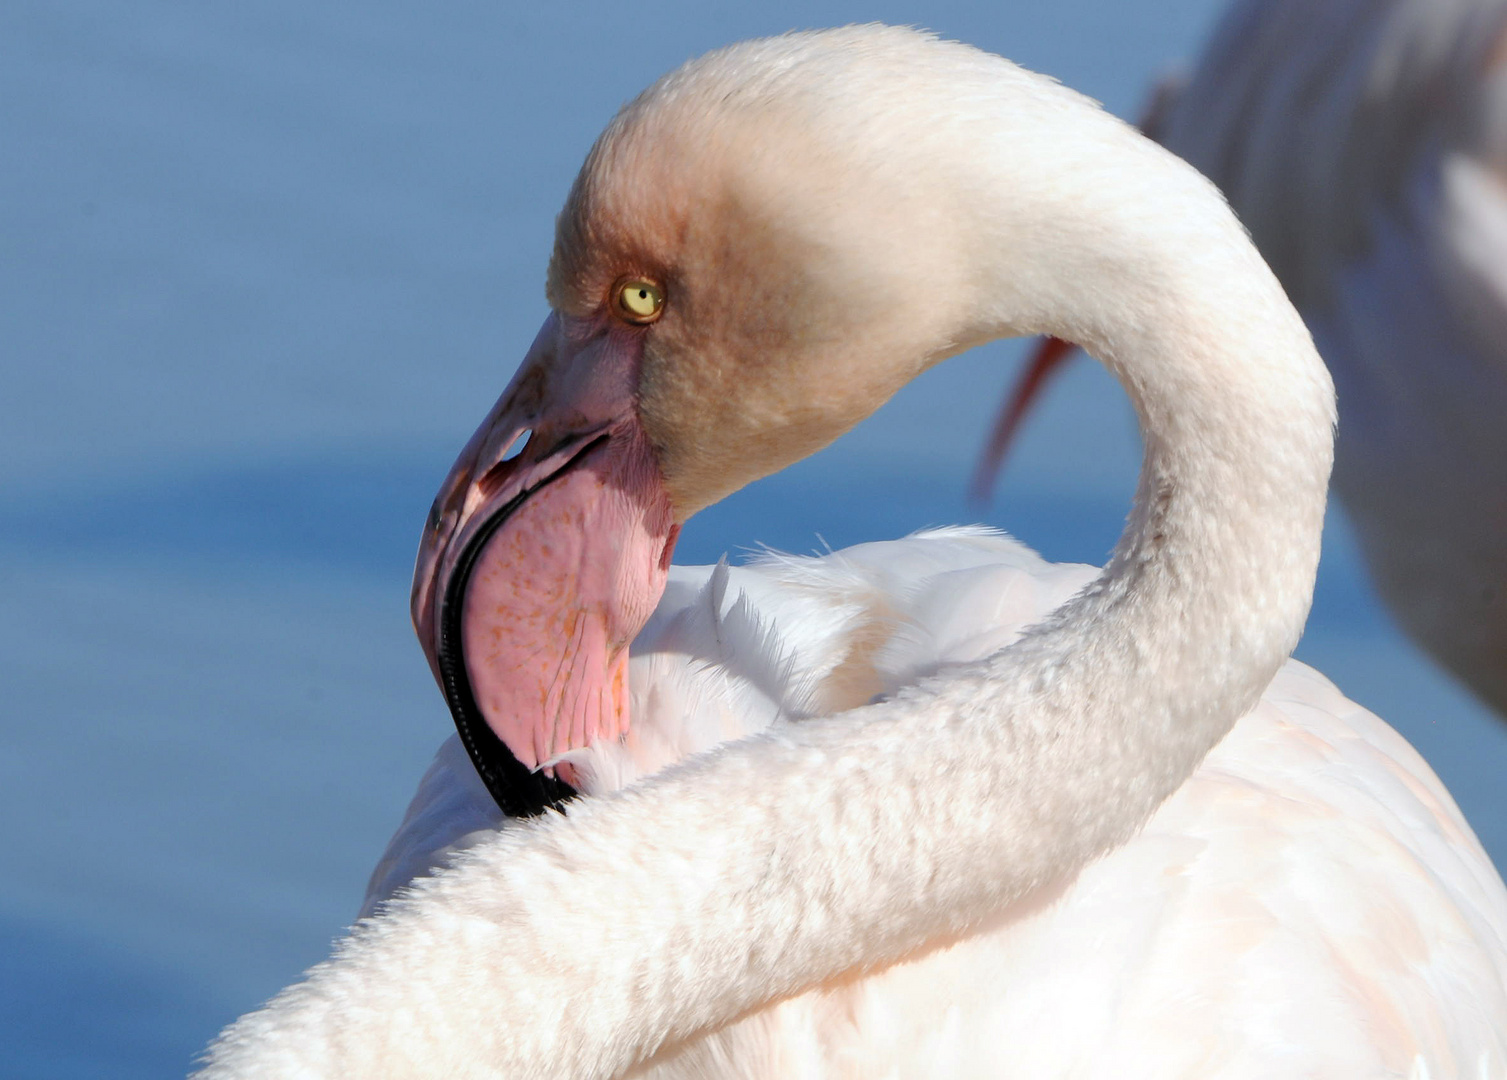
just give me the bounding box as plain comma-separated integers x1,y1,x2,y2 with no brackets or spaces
975,0,1507,714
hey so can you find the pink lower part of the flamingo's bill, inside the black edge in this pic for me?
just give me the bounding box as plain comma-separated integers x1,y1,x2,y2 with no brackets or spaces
461,409,678,783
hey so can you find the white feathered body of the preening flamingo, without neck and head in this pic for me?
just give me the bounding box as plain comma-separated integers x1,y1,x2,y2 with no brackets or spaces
363,529,1507,1080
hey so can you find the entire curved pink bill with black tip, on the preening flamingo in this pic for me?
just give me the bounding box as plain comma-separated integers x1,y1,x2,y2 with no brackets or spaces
413,315,678,815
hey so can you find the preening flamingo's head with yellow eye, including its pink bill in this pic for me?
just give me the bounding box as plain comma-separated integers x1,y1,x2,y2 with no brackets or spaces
413,27,1060,809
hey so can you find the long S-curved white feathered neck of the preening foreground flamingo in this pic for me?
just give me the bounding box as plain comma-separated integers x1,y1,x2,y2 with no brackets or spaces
194,40,1334,1077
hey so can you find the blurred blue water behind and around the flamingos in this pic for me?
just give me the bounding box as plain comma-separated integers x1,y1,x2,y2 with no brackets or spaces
0,0,1507,1078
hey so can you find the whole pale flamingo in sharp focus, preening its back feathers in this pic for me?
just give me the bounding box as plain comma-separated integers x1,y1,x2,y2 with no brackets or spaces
200,26,1507,1080
